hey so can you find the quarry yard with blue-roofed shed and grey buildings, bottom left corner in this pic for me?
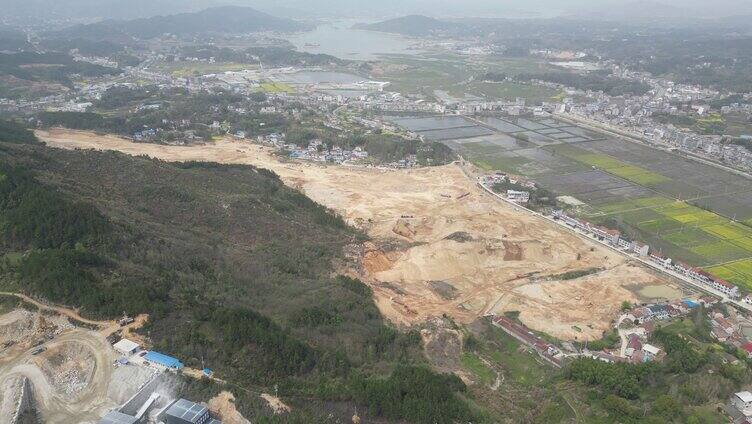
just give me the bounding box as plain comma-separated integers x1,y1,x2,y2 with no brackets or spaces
0,294,236,424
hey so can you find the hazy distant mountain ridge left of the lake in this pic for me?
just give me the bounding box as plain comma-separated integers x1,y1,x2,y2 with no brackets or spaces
53,6,309,40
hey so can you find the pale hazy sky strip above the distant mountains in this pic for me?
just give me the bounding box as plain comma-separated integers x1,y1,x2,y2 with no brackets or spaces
5,0,752,22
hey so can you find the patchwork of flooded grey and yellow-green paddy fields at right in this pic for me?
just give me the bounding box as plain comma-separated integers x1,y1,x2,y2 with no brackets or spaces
388,112,752,291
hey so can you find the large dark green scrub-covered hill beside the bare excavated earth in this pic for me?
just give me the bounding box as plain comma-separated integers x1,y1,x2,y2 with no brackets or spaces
0,123,477,423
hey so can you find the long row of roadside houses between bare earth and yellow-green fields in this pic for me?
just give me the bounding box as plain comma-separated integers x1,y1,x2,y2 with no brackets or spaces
553,210,740,303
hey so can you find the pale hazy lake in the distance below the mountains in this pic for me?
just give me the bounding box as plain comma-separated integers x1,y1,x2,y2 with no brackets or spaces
287,20,419,60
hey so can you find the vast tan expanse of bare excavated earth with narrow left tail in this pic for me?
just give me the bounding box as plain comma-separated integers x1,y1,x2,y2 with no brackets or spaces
37,129,680,340
